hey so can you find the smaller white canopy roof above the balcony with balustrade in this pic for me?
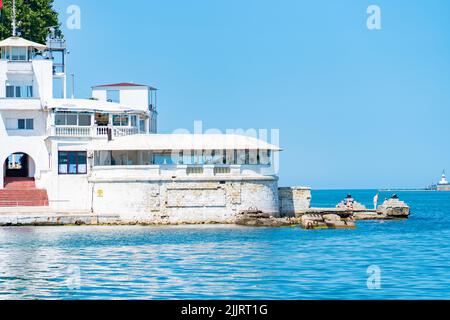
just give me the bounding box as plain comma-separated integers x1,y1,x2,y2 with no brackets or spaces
46,99,149,113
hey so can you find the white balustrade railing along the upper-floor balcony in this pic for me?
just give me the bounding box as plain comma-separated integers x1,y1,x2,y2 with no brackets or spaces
50,126,139,138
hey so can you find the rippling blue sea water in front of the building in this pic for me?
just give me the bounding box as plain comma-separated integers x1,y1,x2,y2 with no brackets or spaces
0,190,450,299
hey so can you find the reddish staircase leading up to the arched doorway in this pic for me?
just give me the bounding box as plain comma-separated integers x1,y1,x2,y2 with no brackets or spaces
0,178,48,207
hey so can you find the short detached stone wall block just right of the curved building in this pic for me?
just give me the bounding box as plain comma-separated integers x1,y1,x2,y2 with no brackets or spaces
278,187,311,217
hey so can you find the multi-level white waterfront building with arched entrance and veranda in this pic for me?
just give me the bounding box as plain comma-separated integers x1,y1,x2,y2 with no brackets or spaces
0,37,309,222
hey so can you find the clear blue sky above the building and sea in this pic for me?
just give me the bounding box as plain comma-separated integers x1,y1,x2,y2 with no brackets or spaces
55,0,450,188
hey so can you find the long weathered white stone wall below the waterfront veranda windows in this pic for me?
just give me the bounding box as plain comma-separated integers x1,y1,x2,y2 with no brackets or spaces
87,178,279,223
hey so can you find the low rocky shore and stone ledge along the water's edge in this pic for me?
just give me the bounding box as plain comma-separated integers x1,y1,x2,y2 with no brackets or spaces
0,196,410,230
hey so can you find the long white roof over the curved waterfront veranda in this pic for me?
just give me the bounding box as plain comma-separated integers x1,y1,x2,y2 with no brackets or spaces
89,134,281,151
